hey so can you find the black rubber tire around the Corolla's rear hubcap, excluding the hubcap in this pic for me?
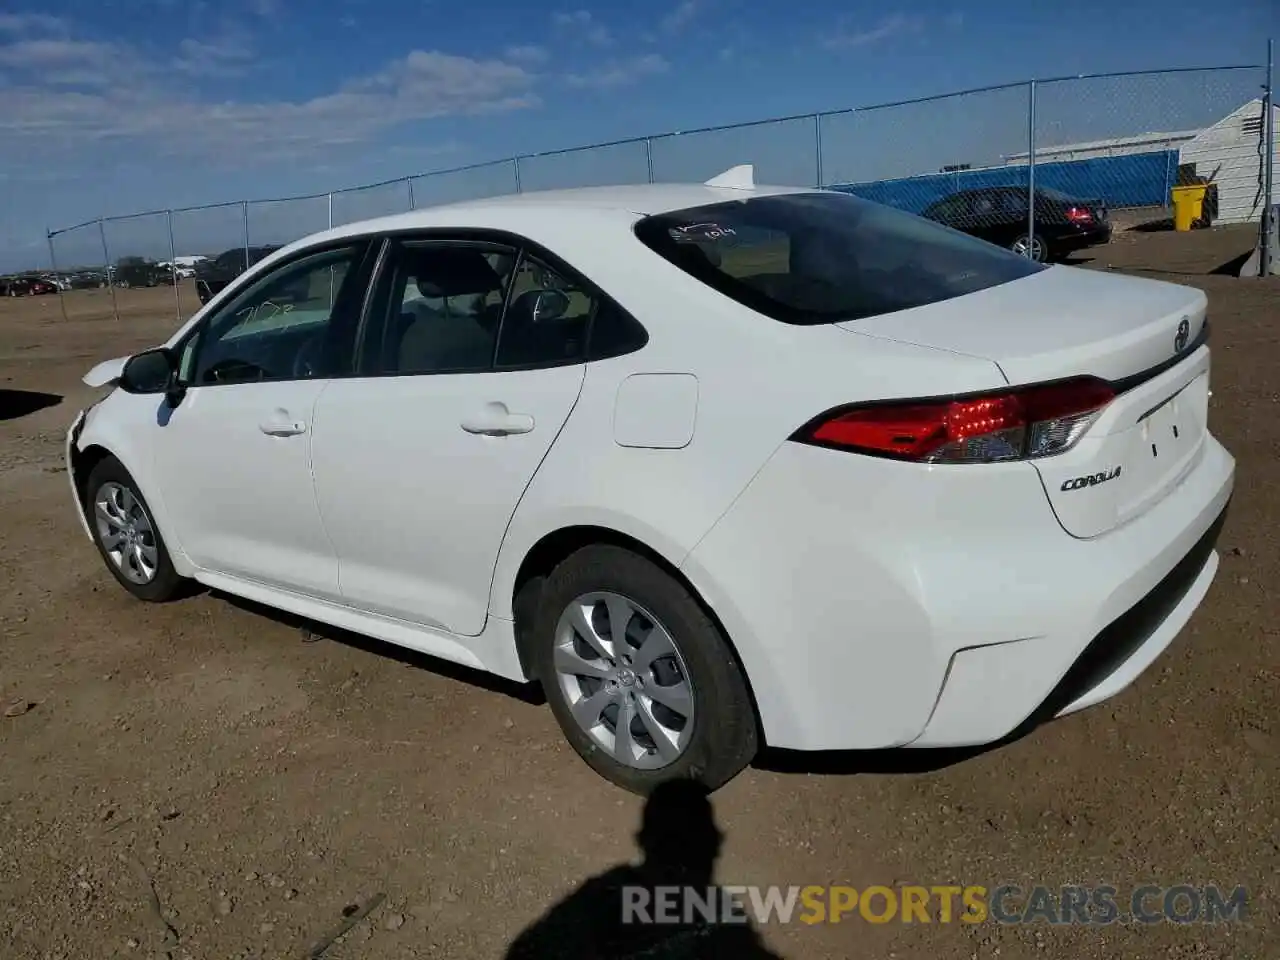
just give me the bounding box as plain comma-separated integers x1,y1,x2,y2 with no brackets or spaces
532,544,759,795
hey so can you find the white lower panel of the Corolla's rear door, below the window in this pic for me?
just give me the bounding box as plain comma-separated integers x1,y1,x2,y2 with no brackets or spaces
312,365,584,636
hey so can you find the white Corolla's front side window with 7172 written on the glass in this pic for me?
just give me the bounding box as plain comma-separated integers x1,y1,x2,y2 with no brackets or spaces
179,246,364,387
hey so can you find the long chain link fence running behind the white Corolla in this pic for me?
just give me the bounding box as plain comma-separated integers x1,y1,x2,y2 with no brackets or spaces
40,65,1274,325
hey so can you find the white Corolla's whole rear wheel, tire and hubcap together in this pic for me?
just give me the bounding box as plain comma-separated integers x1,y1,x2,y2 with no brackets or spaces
534,545,758,794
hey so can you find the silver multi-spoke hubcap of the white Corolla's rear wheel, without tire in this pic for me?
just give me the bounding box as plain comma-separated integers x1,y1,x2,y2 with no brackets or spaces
556,593,694,769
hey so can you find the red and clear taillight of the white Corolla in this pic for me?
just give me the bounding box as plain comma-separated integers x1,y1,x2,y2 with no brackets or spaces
791,378,1115,463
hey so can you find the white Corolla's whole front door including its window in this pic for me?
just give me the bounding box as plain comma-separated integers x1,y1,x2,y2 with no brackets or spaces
154,242,367,599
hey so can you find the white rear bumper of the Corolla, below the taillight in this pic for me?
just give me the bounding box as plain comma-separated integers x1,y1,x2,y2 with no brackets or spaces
684,436,1235,750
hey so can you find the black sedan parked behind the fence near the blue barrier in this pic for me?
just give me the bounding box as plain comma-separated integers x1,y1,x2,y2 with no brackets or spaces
920,187,1111,264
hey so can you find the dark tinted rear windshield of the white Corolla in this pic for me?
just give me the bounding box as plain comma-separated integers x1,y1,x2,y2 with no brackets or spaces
636,192,1043,324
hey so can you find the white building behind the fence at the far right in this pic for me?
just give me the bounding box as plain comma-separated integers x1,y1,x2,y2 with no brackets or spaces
1179,100,1280,223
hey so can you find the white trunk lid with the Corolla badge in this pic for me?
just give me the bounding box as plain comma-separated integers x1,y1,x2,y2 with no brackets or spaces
840,266,1210,538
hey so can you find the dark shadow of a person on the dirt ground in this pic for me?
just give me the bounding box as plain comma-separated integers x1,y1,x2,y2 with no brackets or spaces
507,781,781,960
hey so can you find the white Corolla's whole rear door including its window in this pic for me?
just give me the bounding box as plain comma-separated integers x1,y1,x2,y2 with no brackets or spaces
312,236,596,636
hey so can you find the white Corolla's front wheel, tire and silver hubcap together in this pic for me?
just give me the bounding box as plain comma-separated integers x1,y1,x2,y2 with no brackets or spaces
84,457,183,603
